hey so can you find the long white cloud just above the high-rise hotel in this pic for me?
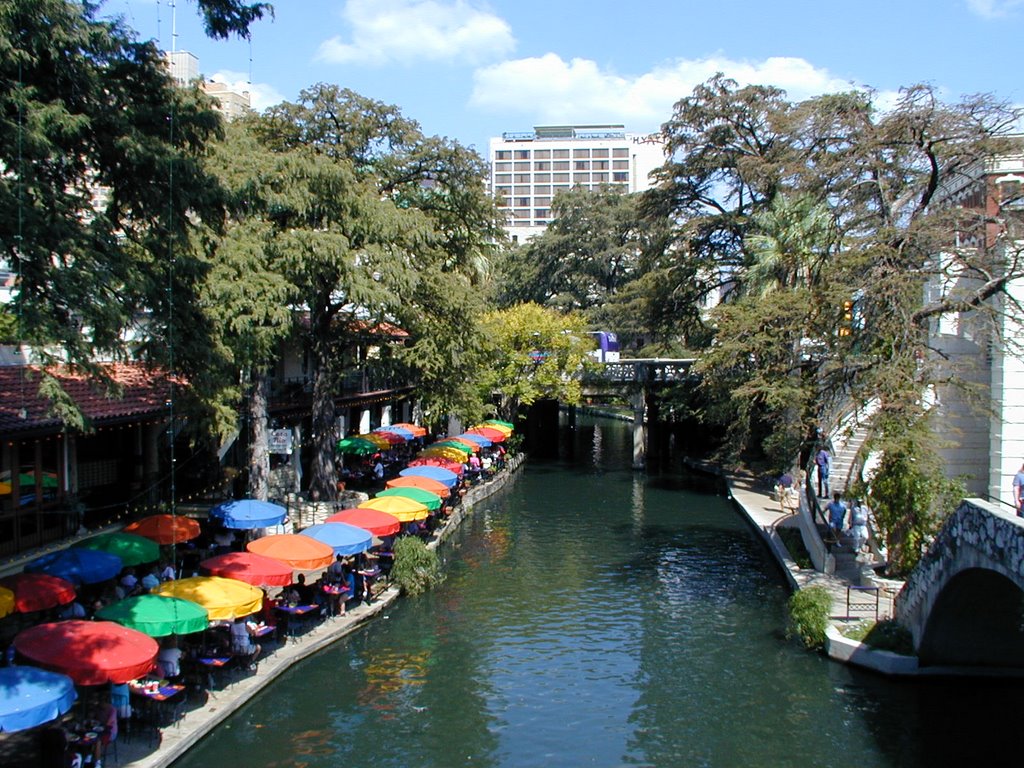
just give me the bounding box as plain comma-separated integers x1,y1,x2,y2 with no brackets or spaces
470,53,886,131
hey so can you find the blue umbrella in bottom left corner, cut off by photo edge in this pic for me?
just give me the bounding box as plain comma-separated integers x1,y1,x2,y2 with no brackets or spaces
0,667,78,733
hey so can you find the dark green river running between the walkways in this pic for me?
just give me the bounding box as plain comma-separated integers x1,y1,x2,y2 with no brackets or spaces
175,420,1024,768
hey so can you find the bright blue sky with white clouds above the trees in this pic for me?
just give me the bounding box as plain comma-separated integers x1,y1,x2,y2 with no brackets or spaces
112,0,1024,155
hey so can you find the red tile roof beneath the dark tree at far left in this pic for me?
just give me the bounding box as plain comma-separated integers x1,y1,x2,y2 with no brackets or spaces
0,362,170,434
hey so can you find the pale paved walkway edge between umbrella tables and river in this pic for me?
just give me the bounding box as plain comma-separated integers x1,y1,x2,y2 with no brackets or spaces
0,454,525,768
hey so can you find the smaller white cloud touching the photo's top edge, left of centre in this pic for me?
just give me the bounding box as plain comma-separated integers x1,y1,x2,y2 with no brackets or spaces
318,0,515,66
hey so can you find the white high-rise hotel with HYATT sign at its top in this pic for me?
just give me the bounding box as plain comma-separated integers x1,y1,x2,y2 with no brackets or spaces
490,125,665,242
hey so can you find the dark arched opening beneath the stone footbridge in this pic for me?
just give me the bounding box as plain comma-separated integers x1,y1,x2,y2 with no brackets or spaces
918,568,1024,668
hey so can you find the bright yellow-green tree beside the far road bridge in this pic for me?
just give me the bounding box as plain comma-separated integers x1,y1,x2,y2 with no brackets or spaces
480,303,594,420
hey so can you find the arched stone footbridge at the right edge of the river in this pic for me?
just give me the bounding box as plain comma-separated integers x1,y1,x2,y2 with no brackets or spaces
896,499,1024,669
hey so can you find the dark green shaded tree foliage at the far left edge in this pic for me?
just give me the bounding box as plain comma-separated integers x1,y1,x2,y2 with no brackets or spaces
0,0,220,421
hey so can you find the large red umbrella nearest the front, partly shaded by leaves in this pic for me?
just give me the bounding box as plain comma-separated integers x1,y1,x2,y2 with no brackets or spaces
14,620,160,685
